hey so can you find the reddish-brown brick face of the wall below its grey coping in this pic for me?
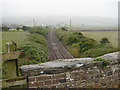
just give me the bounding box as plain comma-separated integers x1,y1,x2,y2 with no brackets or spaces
28,66,119,88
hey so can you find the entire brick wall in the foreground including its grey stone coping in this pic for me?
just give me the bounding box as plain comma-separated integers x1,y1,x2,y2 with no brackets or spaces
21,53,120,88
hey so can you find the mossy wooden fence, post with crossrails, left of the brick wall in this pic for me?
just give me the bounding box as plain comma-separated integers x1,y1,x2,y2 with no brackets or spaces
0,41,27,88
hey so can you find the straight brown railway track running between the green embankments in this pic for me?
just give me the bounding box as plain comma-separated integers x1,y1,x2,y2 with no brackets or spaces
47,30,74,60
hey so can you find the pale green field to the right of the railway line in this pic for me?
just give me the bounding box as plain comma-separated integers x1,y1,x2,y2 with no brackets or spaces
82,31,118,48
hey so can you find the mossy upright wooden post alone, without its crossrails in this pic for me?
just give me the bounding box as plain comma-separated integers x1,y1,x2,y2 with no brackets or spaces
3,41,18,78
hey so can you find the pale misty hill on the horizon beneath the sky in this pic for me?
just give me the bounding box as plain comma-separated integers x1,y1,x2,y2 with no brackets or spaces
2,16,118,27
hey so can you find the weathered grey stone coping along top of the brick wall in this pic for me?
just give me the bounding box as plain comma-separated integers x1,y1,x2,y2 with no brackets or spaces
21,52,120,76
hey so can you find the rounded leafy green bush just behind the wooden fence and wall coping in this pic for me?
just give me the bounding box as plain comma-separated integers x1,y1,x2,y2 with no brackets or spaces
19,42,48,63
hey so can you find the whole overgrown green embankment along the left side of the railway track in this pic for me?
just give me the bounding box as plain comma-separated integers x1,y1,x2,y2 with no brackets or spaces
19,27,49,65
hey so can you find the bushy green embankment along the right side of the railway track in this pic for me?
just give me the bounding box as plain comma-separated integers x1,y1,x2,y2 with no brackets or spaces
56,29,117,58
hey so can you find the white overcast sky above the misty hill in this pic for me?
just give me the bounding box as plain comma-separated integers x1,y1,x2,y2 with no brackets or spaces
2,0,119,18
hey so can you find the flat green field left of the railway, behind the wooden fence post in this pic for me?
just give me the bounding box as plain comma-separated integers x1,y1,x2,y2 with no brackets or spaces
0,32,29,52
